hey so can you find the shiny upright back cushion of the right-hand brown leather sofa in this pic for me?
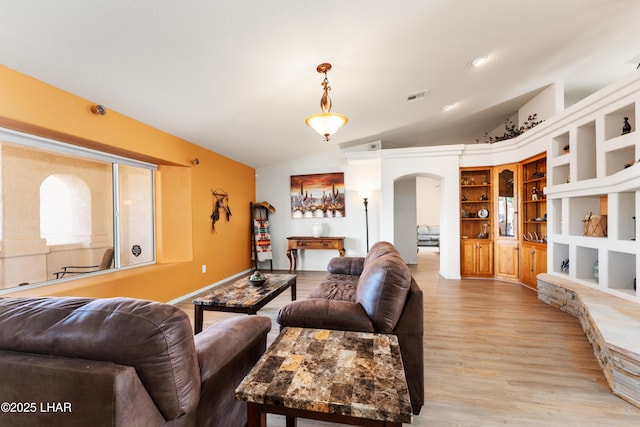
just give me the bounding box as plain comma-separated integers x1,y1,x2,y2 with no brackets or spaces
356,251,411,333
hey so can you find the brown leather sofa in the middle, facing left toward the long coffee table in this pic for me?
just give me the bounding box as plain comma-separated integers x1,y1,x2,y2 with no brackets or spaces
277,242,424,415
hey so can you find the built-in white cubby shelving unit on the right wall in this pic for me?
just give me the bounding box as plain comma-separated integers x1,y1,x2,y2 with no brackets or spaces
545,73,640,302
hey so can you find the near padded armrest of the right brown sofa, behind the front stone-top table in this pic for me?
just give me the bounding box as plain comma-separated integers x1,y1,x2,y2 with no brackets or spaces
276,298,375,332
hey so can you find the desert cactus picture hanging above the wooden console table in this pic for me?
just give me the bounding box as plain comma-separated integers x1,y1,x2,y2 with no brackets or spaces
291,172,345,218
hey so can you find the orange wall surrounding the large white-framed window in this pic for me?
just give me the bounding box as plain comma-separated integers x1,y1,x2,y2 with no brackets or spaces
0,65,255,301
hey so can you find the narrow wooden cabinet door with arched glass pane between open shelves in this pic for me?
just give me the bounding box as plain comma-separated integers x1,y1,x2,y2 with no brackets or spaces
493,163,520,282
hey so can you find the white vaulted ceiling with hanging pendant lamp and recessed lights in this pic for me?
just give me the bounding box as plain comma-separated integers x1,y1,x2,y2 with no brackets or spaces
0,0,640,168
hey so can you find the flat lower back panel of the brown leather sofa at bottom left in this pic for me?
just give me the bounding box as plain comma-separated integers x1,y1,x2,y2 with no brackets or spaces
0,350,166,426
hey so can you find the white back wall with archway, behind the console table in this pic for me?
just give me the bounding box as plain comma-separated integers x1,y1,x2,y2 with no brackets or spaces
252,85,561,279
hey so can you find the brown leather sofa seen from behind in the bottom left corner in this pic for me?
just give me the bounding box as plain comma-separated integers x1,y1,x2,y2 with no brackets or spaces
0,297,271,427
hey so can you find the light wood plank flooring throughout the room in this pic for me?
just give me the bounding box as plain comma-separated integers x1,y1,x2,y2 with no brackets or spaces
178,248,640,427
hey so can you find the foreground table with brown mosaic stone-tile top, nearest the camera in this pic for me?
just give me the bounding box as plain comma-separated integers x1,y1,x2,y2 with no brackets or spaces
236,327,413,427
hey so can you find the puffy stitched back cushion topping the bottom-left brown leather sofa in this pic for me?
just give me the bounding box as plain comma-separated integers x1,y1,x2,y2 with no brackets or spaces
0,297,200,420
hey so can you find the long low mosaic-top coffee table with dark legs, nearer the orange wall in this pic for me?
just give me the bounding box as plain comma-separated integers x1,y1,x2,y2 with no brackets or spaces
193,274,296,334
